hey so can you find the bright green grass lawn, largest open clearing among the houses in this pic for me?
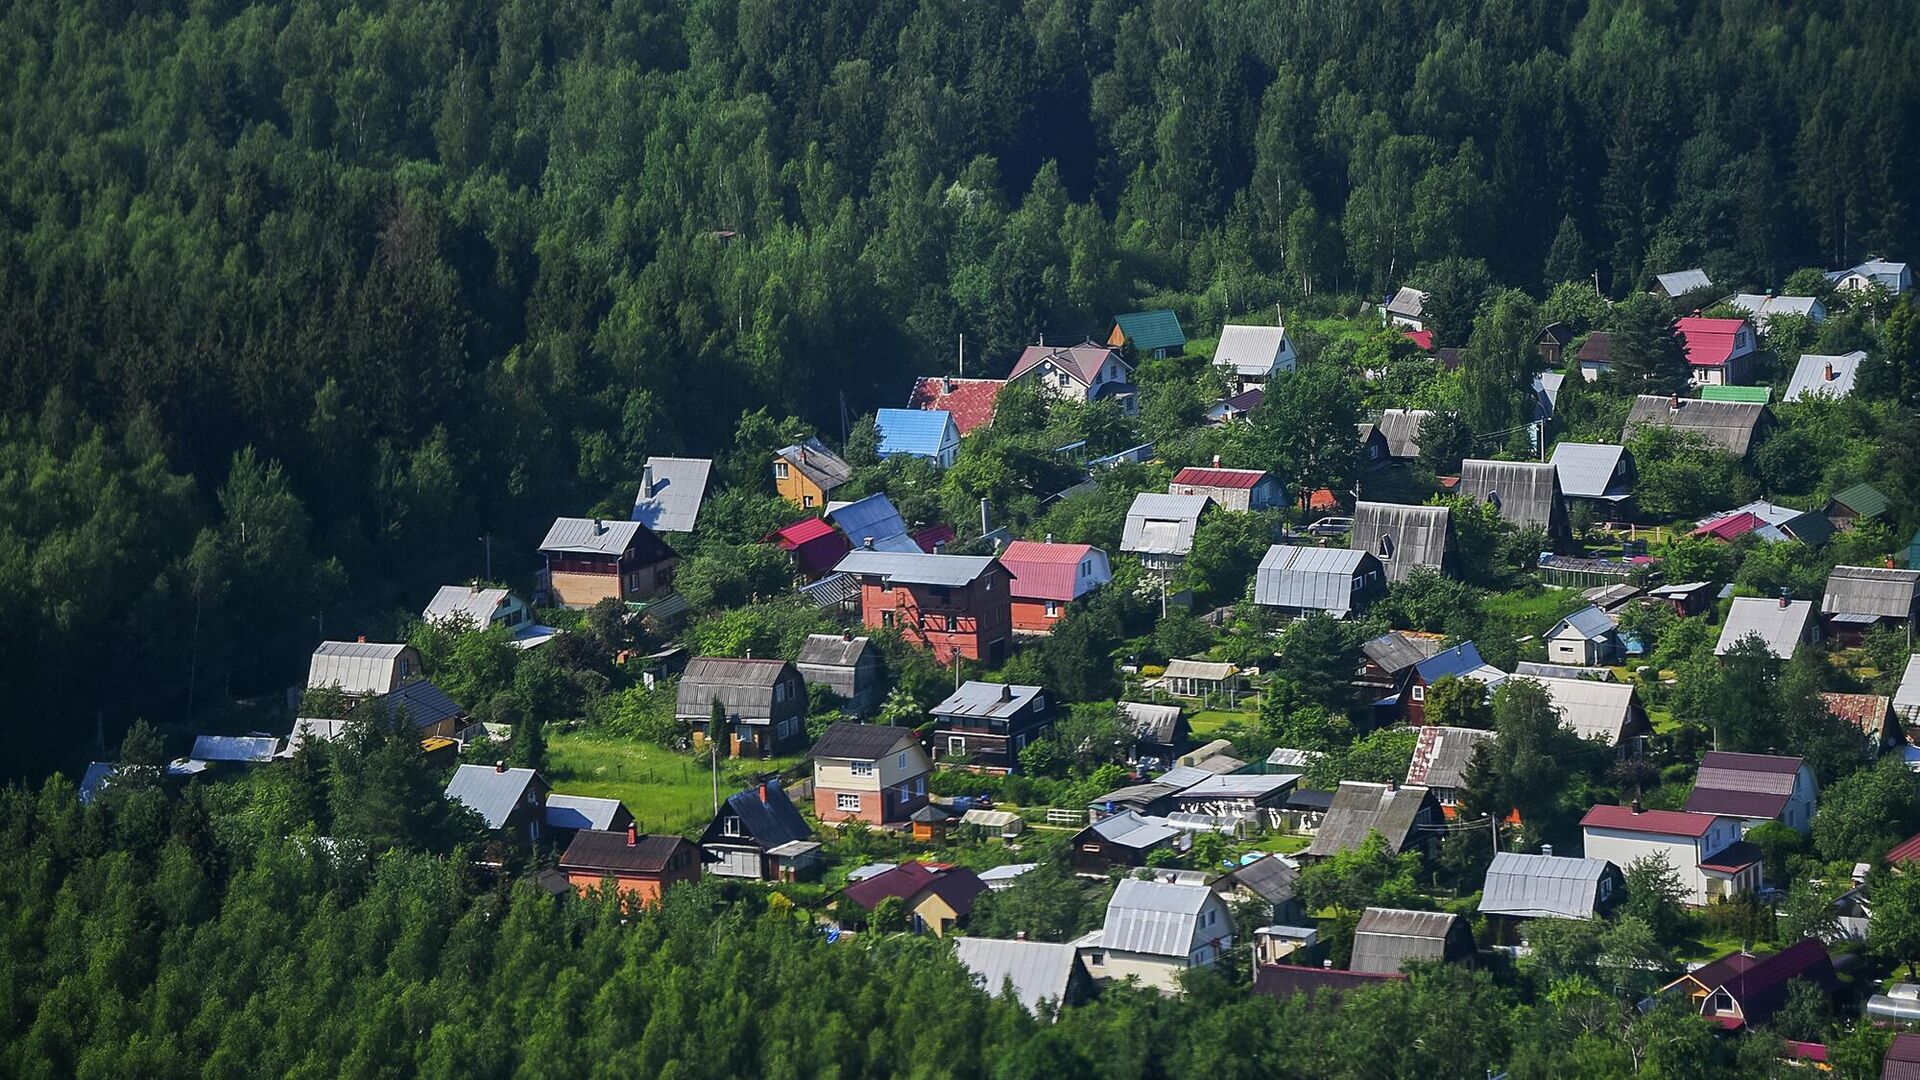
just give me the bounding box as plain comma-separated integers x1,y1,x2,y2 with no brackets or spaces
547,732,797,832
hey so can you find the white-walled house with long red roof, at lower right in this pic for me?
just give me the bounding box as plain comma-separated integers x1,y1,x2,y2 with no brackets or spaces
1580,801,1761,907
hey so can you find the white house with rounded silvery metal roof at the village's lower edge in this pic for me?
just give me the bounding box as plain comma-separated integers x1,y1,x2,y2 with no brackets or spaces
1073,878,1233,994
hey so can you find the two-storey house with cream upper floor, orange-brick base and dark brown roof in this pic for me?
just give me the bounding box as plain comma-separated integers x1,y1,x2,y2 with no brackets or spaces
808,721,933,824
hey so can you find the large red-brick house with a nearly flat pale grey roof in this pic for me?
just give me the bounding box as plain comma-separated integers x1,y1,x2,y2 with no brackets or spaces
833,548,1014,665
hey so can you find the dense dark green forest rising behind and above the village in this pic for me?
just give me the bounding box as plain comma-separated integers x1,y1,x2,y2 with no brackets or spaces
0,0,1920,773
